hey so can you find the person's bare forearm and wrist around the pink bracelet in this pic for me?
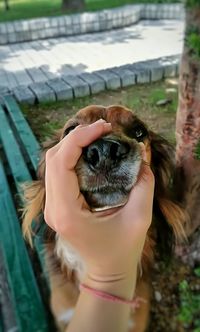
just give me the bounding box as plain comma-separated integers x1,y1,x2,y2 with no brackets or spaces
67,272,136,332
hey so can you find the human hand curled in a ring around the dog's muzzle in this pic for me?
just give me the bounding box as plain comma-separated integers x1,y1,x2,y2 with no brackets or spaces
44,121,154,290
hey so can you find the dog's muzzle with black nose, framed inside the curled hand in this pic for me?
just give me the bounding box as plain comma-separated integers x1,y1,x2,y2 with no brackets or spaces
76,136,141,211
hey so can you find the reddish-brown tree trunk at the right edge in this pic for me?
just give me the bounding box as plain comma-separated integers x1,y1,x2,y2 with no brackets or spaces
176,0,200,235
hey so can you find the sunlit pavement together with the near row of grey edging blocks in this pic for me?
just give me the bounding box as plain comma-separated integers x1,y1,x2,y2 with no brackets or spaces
0,14,184,104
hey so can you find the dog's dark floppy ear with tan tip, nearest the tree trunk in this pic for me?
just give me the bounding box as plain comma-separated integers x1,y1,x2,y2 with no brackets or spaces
149,131,186,258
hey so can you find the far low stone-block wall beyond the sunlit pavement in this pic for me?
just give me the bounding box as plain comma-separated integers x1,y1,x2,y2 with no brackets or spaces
0,4,184,45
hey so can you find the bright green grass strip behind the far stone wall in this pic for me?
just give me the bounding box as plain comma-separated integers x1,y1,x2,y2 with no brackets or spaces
0,0,179,22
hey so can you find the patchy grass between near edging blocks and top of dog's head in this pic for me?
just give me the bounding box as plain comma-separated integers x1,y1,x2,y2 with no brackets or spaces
22,81,177,143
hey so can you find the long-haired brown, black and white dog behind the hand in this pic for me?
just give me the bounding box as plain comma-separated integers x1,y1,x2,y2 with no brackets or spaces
23,105,186,332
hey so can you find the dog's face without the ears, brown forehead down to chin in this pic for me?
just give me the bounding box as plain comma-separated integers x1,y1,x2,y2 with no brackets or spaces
63,106,150,211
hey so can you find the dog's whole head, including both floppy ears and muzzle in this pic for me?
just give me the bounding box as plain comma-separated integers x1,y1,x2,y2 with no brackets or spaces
23,105,185,264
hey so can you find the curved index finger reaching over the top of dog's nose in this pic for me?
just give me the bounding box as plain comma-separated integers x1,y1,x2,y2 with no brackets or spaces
48,120,111,208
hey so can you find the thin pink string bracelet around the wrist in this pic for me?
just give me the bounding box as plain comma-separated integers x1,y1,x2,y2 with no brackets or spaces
79,284,147,309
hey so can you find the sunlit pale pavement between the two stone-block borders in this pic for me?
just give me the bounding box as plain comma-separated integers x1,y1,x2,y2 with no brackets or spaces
0,20,184,89
